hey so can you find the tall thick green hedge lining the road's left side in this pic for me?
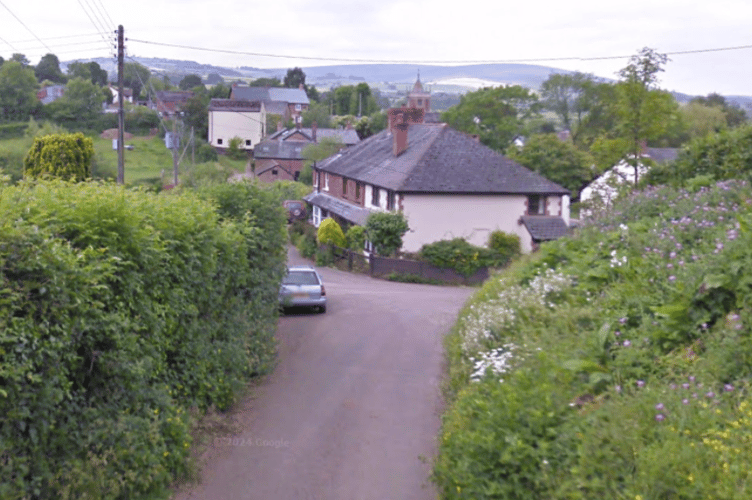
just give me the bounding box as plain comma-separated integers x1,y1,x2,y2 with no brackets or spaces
0,181,285,499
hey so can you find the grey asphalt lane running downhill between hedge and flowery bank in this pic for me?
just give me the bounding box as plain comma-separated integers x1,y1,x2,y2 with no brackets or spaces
175,251,473,500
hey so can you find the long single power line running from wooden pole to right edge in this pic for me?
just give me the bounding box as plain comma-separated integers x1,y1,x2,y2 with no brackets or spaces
128,38,752,64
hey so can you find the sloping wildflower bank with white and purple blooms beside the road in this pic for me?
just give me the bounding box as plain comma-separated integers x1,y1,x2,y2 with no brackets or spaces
433,181,752,500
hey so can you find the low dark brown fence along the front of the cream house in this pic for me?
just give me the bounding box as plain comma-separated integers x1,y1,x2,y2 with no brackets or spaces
332,246,489,285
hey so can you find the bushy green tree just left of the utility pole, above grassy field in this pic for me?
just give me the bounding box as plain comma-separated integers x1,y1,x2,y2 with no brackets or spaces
44,77,106,127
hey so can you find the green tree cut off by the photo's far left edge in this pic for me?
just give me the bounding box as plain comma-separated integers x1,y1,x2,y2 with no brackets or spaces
0,60,41,121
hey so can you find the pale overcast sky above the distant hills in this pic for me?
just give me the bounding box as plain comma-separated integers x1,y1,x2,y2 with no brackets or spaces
0,0,752,96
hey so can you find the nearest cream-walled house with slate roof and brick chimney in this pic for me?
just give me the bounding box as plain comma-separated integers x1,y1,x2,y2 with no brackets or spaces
305,109,569,252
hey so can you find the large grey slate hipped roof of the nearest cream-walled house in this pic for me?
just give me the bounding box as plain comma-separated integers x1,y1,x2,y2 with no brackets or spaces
319,124,569,195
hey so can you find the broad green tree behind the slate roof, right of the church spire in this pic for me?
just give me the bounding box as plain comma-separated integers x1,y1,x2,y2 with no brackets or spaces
442,85,540,152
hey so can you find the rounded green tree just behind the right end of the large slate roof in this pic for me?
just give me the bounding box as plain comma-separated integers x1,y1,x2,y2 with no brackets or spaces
509,134,594,202
